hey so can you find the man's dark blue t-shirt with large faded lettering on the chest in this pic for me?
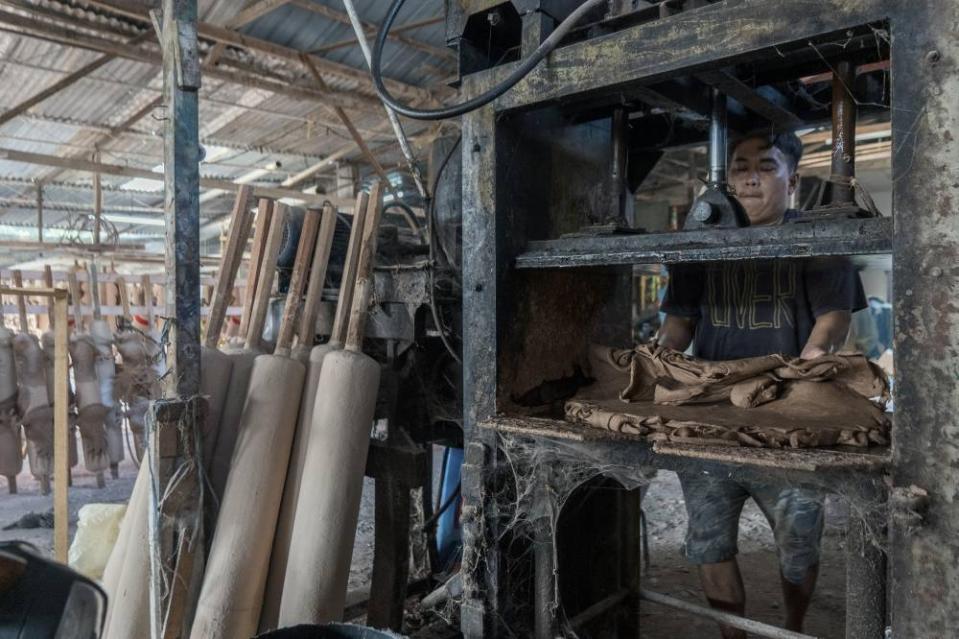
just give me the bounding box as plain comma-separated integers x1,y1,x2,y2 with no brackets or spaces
662,257,866,361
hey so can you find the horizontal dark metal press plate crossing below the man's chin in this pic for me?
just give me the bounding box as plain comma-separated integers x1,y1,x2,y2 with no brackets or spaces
515,217,893,269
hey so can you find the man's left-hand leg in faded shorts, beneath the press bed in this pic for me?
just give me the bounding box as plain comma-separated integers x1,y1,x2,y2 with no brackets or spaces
679,474,748,639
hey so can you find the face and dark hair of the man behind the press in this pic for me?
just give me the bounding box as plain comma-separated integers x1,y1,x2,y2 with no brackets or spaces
729,138,799,226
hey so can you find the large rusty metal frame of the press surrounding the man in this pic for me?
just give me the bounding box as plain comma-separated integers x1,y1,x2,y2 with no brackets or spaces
462,0,959,639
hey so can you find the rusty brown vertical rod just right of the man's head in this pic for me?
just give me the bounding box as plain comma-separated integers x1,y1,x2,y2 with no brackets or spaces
830,60,856,205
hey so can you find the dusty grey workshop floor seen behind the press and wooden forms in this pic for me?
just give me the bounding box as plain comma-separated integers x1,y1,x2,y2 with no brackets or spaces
0,450,845,639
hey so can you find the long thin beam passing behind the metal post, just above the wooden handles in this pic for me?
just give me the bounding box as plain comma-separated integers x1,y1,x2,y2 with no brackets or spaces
0,145,353,208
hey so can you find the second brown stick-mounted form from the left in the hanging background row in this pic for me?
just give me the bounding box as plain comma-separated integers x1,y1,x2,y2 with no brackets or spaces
13,271,53,495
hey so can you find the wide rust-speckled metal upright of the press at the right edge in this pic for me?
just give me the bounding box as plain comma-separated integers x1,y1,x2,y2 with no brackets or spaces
891,0,959,639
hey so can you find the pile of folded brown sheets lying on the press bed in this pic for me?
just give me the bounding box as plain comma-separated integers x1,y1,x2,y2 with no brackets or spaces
566,345,890,448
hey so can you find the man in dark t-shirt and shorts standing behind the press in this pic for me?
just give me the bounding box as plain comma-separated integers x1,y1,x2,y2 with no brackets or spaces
659,133,866,639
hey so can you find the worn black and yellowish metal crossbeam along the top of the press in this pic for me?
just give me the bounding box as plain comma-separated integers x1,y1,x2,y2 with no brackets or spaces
469,0,897,111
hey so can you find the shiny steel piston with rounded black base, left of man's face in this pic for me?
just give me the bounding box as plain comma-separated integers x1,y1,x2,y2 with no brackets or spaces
683,88,749,231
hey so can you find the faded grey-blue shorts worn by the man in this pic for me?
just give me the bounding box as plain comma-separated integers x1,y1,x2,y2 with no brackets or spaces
679,474,825,584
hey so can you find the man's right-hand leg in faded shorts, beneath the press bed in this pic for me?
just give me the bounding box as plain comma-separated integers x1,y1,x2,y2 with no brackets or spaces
752,486,825,632
